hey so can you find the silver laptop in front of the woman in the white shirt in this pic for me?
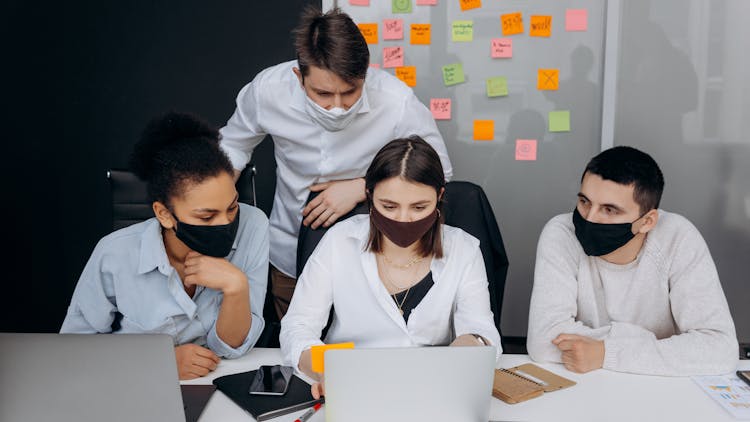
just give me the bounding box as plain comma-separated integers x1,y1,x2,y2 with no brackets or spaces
324,346,496,422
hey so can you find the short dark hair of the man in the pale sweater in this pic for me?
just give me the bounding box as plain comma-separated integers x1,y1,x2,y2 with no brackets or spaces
581,146,664,214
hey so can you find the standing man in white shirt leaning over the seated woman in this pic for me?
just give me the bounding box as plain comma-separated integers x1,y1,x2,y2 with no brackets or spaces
221,8,452,318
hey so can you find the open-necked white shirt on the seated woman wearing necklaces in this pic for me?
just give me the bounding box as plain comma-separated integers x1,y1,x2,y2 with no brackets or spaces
279,215,502,367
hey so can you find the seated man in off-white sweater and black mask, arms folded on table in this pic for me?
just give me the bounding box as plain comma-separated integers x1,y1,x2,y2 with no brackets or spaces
527,146,739,376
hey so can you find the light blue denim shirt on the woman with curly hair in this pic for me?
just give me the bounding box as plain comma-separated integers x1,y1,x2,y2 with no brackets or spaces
60,203,268,358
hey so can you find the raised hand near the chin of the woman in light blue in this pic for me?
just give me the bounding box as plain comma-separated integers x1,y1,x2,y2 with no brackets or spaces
182,251,248,295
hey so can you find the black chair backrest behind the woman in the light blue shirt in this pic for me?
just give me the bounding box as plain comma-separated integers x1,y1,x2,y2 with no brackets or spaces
107,164,257,230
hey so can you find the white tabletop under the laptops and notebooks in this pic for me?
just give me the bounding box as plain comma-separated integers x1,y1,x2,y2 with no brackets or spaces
182,348,750,422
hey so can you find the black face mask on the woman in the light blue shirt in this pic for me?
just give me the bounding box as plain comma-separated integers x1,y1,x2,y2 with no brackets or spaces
172,208,240,258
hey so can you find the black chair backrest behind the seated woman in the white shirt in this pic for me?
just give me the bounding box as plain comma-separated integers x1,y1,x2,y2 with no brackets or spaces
297,181,508,331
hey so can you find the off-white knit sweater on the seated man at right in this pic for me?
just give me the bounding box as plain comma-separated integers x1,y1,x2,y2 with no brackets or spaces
527,210,739,376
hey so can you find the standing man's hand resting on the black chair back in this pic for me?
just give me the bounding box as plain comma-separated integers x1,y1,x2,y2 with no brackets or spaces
302,178,365,229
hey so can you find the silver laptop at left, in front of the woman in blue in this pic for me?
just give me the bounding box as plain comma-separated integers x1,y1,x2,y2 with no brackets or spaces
0,333,185,422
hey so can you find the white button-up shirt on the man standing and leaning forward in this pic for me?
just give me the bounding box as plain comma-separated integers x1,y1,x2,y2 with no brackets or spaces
221,61,453,277
